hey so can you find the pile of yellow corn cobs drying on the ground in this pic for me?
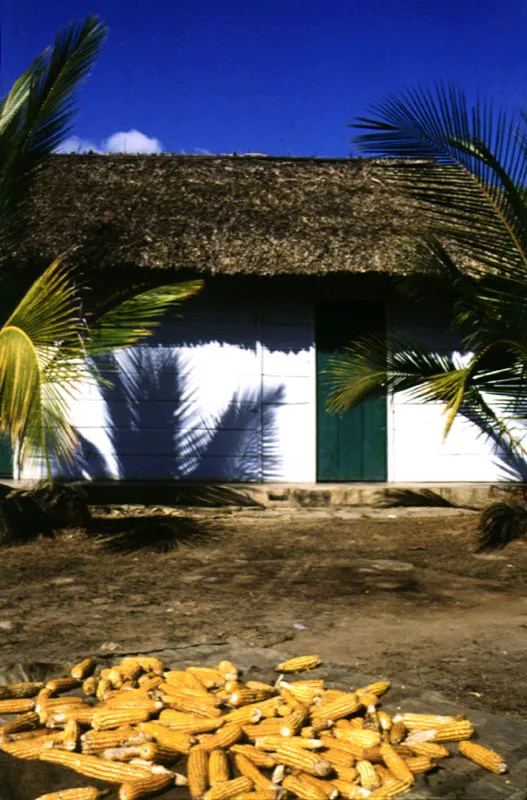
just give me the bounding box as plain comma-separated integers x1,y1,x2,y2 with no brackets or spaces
0,656,507,800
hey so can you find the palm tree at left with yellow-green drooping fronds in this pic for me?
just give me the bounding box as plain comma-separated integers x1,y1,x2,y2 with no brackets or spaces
0,17,201,480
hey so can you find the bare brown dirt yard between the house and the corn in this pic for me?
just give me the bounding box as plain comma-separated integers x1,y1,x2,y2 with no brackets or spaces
0,500,527,718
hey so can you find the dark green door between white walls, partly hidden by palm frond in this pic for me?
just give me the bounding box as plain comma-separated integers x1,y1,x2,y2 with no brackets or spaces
316,299,386,481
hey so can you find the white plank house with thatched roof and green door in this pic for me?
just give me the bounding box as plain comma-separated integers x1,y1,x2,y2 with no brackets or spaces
9,155,518,483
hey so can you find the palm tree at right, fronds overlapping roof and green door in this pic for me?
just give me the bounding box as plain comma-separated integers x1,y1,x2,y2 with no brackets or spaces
330,85,527,547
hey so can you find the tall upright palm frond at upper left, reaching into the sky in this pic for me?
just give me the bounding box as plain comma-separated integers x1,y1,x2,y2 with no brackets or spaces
0,17,107,248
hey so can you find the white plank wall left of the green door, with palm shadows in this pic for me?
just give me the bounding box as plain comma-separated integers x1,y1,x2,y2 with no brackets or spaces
25,298,316,482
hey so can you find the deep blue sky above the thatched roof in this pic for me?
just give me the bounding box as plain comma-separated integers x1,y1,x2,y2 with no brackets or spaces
4,0,527,156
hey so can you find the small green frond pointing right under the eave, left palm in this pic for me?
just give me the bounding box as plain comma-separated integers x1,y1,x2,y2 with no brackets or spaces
87,280,203,355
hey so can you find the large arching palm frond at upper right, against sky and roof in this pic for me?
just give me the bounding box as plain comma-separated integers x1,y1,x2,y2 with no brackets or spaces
354,85,527,280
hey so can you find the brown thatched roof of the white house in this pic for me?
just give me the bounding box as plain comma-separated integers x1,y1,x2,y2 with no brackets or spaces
19,154,426,275
